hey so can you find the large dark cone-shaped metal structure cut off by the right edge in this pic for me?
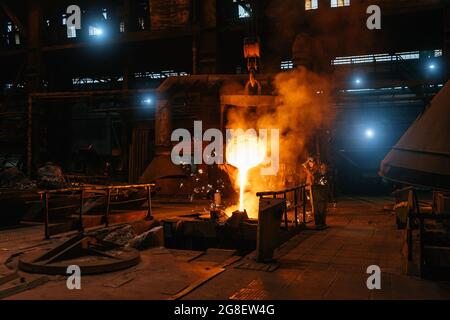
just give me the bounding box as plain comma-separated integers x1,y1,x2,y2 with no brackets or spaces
380,81,450,190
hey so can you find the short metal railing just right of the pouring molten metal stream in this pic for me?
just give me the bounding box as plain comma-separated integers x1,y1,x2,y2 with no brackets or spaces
256,185,308,230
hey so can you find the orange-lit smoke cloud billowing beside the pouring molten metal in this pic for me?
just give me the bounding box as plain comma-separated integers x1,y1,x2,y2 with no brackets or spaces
226,67,334,216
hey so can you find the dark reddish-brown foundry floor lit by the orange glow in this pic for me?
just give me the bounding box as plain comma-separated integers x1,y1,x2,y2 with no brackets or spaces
0,197,450,300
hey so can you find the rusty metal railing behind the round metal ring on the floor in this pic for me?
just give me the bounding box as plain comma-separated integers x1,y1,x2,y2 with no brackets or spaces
39,184,155,239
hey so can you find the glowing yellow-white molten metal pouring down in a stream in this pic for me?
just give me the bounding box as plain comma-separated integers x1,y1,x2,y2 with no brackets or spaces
227,133,266,211
